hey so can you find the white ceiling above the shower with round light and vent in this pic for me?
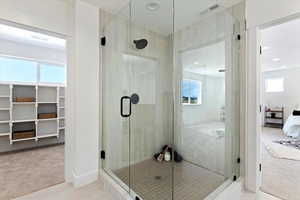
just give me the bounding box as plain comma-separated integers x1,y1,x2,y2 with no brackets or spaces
94,0,243,35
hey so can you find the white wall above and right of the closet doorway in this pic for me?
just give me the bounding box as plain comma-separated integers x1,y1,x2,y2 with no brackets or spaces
0,0,99,186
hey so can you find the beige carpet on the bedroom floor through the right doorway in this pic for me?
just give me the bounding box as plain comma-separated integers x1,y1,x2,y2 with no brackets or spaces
261,128,300,200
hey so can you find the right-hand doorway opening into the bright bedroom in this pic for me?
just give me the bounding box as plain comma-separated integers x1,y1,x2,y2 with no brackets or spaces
259,18,300,200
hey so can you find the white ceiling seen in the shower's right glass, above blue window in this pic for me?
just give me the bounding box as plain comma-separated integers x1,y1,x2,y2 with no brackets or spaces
181,41,225,77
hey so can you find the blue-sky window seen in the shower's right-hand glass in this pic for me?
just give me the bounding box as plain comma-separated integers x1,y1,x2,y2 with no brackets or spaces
182,79,202,105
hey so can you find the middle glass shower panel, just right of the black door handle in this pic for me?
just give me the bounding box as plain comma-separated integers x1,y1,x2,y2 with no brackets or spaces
126,0,173,200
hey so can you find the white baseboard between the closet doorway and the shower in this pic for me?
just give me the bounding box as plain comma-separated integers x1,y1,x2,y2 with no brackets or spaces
73,170,99,188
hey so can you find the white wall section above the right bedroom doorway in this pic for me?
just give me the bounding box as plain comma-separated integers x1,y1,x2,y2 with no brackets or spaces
246,0,300,28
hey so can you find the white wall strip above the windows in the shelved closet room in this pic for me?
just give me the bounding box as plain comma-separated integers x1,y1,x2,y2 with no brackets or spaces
0,39,66,63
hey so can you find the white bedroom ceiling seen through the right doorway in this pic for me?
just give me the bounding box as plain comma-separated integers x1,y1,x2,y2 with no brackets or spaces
261,19,300,71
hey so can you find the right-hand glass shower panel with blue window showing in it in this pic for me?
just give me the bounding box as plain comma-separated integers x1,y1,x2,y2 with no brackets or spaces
173,0,243,200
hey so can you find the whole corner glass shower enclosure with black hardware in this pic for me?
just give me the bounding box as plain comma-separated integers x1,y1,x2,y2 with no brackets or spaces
102,0,244,200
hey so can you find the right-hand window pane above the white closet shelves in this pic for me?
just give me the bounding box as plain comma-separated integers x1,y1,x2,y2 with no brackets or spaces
40,64,66,83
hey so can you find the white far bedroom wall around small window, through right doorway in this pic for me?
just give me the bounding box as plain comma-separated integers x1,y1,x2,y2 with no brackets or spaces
262,68,300,120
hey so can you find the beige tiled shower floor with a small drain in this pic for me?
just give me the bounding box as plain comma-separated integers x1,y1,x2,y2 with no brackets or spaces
115,160,225,200
